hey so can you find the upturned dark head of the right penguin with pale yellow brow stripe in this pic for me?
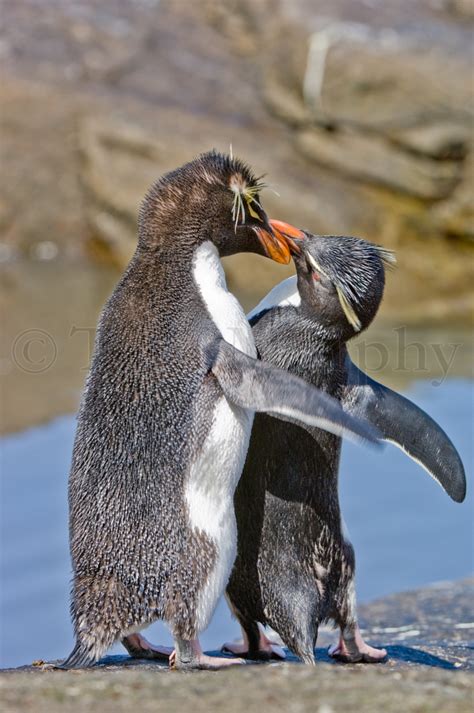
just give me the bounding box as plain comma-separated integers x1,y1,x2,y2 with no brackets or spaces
294,233,395,340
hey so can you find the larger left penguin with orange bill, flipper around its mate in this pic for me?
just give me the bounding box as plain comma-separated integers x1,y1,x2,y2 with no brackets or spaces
64,152,382,668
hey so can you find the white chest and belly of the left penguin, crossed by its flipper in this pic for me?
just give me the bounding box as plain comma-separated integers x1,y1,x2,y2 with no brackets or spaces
185,242,257,631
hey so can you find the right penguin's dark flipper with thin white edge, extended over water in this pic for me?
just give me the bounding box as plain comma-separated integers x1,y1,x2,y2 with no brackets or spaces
342,357,466,503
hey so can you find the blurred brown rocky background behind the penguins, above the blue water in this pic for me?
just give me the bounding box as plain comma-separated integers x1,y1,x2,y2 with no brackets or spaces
0,0,474,430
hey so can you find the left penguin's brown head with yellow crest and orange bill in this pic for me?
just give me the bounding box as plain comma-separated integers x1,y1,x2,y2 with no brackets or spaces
139,150,304,263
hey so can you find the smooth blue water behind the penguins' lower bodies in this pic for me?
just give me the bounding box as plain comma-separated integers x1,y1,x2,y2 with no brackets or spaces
0,380,474,667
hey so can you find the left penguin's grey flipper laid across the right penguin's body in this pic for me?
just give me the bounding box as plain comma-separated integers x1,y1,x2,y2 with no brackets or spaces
211,339,379,443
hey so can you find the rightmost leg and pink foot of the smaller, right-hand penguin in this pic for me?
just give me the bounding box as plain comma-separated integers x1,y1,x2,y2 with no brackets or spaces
328,541,387,663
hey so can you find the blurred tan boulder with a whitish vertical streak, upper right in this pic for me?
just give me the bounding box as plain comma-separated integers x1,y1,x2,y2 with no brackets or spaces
265,0,474,131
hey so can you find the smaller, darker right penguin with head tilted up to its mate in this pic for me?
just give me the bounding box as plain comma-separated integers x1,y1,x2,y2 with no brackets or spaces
224,235,466,664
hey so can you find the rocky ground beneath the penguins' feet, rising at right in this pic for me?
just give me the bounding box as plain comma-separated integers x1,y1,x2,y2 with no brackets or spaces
0,579,474,713
